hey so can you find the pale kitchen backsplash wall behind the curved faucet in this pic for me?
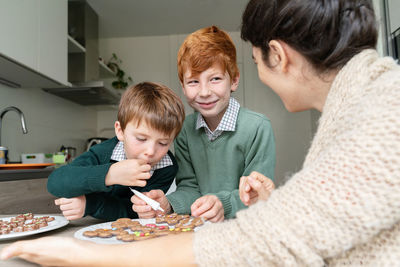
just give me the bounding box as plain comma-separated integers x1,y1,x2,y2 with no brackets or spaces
0,85,97,161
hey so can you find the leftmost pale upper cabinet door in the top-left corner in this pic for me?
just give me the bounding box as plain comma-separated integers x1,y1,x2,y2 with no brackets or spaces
0,0,39,69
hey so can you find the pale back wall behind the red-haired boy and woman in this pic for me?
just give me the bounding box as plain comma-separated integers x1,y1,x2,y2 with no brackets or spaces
97,32,318,184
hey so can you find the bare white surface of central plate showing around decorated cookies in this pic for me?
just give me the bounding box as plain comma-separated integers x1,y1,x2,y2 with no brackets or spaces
74,218,208,244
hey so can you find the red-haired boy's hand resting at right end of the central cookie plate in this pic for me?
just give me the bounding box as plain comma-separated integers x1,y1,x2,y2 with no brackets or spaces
190,195,224,222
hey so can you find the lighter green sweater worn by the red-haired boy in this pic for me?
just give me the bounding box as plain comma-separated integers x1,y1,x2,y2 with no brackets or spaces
167,108,275,218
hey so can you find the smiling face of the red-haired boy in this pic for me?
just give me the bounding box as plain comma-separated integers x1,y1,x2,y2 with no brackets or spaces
182,65,239,128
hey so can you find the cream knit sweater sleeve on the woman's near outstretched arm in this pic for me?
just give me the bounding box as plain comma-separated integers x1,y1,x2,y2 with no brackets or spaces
194,105,400,266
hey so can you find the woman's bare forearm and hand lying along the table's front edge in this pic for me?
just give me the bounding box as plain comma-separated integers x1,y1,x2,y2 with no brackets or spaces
0,233,196,267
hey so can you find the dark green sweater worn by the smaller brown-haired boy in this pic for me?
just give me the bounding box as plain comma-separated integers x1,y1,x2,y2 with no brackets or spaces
47,137,178,221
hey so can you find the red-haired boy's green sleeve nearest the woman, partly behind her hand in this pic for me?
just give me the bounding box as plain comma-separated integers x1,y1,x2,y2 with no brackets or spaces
215,119,275,219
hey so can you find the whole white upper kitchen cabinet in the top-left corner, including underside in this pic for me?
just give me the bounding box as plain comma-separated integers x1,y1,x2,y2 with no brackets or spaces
0,0,68,88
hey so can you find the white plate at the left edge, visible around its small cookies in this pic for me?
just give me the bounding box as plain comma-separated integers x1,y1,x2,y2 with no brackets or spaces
0,214,69,241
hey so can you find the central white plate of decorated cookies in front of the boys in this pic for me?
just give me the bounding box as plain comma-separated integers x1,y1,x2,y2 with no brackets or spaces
74,213,208,244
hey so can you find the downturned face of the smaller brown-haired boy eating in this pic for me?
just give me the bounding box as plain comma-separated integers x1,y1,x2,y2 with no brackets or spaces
115,121,174,166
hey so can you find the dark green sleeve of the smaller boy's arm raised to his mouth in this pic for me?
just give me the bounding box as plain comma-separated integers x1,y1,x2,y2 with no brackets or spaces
47,150,112,198
